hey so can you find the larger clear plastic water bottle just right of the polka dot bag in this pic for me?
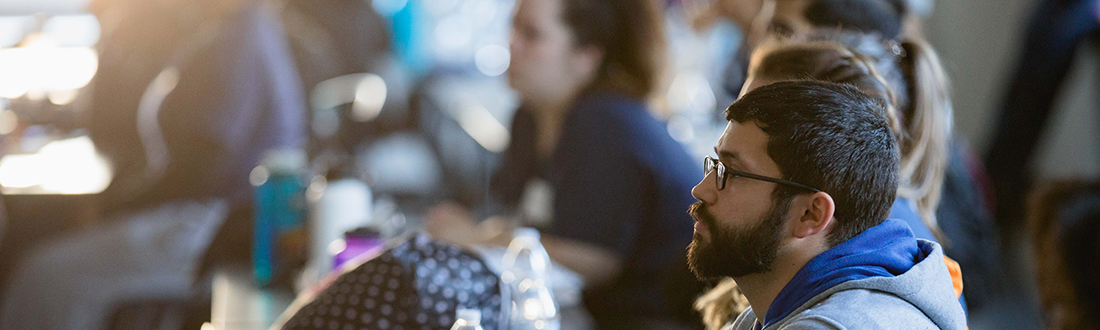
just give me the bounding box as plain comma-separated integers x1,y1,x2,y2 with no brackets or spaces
501,228,561,330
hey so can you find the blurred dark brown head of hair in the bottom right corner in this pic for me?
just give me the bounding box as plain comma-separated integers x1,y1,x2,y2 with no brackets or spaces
1027,180,1100,330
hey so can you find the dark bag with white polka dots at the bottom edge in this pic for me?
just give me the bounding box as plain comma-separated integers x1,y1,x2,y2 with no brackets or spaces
283,235,505,330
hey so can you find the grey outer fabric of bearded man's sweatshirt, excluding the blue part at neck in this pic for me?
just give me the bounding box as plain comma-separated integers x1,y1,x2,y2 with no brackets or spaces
725,240,966,330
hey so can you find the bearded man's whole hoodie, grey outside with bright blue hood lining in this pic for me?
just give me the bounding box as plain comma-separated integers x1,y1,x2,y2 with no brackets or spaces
733,220,966,330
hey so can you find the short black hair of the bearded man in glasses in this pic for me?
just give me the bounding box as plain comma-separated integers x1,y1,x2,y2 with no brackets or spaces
726,80,899,246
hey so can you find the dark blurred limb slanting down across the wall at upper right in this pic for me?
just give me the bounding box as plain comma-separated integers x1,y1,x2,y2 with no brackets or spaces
985,0,1100,242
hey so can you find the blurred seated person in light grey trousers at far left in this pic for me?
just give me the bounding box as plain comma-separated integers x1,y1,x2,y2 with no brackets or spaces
0,0,306,329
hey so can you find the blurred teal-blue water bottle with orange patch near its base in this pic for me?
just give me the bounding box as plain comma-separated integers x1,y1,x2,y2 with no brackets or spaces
249,149,309,286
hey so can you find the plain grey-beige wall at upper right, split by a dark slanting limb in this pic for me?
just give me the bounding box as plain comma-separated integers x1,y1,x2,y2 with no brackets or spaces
926,0,1100,177
